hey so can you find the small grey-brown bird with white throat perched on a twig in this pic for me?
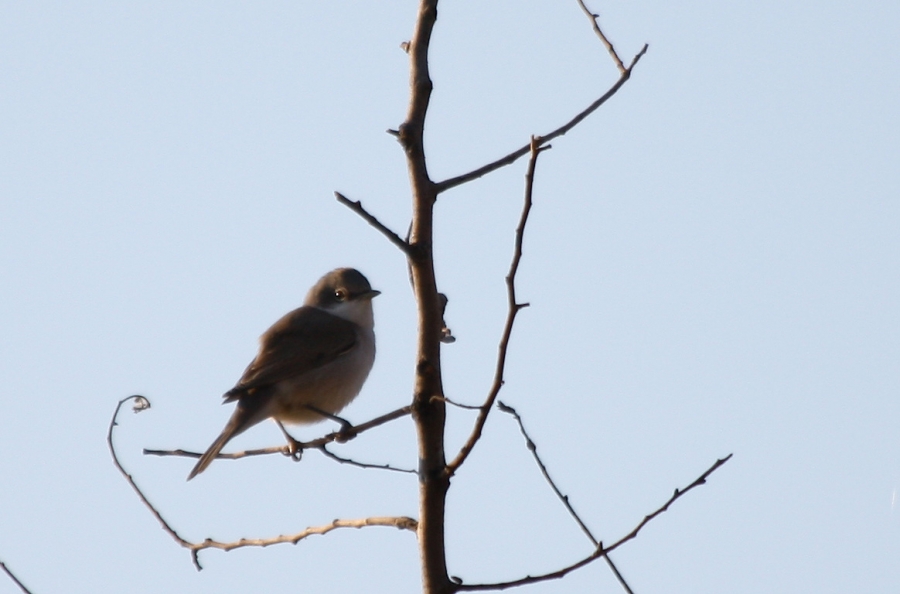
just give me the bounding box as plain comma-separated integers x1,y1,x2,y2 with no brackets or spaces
188,268,380,480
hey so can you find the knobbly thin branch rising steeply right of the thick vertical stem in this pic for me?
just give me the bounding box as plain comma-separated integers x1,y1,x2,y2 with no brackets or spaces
446,136,550,476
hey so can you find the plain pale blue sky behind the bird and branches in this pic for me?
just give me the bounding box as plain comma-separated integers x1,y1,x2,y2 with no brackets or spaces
0,0,900,594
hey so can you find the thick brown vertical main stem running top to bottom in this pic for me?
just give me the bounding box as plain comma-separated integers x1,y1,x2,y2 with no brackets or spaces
398,0,453,594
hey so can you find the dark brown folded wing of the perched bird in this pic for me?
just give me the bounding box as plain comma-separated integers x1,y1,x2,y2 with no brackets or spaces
225,306,357,402
